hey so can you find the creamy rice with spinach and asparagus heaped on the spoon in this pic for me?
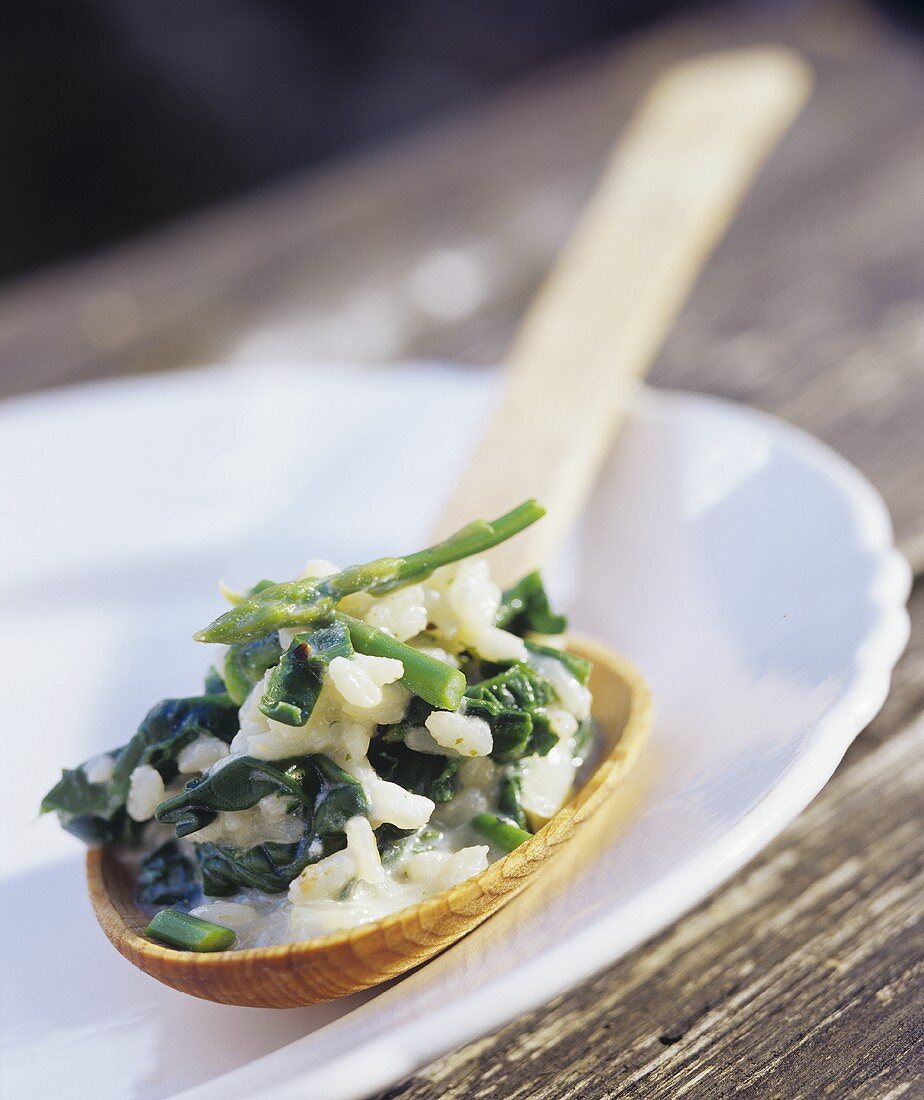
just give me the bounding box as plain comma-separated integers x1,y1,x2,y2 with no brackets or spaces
42,501,593,950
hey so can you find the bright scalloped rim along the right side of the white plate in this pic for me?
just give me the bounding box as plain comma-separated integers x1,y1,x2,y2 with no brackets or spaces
174,386,912,1100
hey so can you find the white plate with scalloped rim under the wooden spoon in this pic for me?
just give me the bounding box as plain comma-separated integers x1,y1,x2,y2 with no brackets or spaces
0,366,910,1100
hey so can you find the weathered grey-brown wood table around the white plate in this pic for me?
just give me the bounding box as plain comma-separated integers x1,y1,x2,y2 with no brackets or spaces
0,4,924,1100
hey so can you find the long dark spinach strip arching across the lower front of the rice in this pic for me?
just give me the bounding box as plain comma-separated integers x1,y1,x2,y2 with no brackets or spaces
155,756,369,837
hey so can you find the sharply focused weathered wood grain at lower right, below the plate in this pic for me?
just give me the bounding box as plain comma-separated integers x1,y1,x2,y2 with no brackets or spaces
380,584,924,1100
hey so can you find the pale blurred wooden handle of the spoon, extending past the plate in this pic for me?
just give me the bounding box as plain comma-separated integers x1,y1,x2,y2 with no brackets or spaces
437,47,811,582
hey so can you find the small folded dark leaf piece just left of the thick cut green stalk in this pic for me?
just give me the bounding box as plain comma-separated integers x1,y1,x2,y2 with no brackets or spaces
260,622,353,726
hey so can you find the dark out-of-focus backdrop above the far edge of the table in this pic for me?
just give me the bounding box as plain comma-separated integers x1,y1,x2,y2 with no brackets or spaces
0,0,922,288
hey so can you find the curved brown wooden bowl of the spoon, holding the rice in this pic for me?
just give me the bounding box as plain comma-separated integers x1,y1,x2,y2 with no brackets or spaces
87,636,652,1009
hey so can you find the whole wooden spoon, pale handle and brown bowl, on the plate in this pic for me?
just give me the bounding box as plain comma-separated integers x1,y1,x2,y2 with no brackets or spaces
87,48,811,1008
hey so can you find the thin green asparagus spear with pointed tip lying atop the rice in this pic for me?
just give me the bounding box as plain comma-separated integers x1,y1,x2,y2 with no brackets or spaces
195,501,545,645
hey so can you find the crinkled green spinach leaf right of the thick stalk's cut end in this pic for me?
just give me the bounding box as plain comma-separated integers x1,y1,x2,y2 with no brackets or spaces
465,662,558,763
